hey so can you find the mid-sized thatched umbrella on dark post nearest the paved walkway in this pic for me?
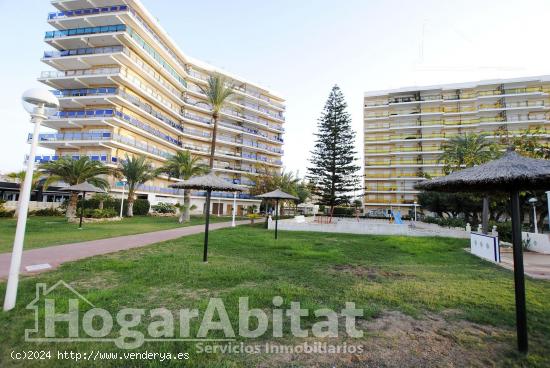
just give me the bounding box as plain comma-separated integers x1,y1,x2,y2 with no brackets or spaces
170,172,243,262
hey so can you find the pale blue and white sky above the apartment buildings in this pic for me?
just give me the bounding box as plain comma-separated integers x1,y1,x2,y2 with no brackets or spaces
0,0,550,175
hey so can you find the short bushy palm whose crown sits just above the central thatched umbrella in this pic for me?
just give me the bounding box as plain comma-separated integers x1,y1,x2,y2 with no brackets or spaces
158,151,209,223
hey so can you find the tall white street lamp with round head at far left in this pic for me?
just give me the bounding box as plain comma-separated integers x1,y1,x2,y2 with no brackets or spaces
4,88,59,311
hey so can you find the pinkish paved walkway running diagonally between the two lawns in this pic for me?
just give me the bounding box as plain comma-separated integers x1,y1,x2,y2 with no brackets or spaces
0,220,249,279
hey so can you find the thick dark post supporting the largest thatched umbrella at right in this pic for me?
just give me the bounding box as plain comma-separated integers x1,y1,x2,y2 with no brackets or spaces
510,191,528,353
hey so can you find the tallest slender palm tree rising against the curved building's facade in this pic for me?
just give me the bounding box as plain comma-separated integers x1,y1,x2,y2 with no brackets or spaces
199,74,233,169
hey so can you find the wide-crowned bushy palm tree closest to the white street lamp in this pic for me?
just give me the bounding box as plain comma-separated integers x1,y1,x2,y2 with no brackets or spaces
39,156,112,217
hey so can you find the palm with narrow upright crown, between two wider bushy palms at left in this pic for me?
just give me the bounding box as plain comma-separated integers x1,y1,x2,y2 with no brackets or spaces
117,155,156,217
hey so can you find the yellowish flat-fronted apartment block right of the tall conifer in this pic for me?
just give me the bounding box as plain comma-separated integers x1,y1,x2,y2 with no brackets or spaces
364,75,550,210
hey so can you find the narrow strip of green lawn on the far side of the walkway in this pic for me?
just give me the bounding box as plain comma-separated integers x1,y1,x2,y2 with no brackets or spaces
0,216,242,253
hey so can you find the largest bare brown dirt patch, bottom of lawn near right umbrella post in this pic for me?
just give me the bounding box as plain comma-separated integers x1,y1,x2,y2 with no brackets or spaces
250,311,515,368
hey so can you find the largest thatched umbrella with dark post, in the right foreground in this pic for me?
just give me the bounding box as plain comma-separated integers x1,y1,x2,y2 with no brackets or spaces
416,150,550,352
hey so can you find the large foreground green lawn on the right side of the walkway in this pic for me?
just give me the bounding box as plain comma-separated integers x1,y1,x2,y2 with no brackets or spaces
0,226,550,367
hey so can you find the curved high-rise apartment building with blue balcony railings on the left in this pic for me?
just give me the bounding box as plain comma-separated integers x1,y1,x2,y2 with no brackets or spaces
35,0,285,214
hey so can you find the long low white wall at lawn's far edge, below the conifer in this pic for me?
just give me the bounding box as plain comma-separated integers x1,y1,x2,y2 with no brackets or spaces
268,217,470,239
